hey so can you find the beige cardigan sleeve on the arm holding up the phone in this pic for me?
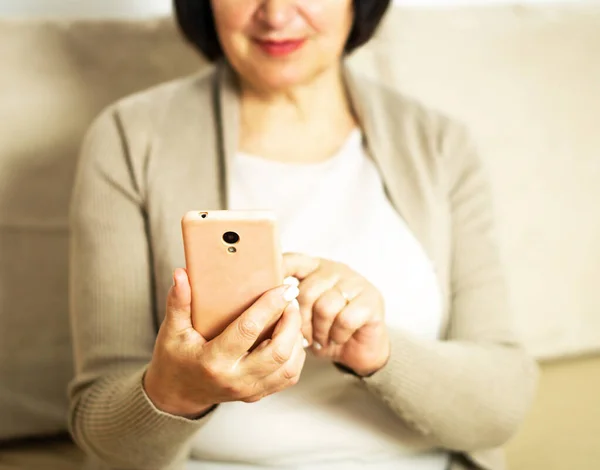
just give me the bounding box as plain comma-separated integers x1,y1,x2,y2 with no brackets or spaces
70,109,203,469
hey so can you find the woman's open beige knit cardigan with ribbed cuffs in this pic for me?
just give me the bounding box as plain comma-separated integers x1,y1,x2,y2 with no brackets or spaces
70,66,537,470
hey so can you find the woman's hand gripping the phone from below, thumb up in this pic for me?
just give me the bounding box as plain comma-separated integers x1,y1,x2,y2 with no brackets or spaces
144,269,306,419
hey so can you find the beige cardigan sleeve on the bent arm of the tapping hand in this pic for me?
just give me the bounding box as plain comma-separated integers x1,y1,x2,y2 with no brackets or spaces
364,120,537,452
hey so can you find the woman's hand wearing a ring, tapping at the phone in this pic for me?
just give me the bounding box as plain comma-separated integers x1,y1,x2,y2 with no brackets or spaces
284,253,390,377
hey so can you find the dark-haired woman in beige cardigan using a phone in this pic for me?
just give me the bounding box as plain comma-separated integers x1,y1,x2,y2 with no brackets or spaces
70,0,536,470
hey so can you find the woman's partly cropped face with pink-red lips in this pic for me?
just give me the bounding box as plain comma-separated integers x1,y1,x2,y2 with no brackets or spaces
211,0,354,90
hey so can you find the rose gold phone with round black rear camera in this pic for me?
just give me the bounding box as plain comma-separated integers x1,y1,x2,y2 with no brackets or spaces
181,211,283,344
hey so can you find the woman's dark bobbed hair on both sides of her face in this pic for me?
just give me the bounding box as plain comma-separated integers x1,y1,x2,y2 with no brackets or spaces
174,0,391,61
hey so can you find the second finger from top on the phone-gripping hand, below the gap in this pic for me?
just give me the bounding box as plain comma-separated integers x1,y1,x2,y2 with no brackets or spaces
241,302,302,377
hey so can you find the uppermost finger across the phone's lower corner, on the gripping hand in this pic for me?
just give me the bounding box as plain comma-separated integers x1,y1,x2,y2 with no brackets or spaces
211,286,299,358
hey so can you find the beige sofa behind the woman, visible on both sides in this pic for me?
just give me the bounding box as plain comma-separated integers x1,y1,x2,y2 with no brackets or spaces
0,3,600,470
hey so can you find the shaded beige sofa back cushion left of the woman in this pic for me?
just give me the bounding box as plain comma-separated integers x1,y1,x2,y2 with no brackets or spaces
0,17,201,440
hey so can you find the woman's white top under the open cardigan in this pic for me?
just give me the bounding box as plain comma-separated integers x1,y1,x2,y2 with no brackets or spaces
192,130,448,470
